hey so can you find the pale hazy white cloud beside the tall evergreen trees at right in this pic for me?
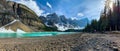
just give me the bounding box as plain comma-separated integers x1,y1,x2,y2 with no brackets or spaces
83,0,105,20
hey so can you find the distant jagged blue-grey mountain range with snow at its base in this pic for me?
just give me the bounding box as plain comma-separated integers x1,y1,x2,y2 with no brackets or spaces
39,13,89,31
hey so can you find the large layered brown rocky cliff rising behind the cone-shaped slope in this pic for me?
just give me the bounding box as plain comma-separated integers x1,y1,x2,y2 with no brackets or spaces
0,0,44,31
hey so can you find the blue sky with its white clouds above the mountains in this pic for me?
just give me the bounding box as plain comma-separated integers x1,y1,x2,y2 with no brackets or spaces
11,0,105,20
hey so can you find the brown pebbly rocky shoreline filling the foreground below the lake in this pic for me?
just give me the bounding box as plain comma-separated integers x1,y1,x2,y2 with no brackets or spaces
0,33,120,51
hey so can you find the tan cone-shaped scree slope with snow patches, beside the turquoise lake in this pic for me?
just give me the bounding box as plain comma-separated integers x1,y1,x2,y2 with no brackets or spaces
0,20,32,32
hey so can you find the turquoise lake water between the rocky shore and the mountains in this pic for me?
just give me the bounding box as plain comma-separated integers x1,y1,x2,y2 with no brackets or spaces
0,32,76,38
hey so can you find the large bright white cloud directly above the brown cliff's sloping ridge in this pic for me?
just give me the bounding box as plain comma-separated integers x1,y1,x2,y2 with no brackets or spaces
12,0,44,16
